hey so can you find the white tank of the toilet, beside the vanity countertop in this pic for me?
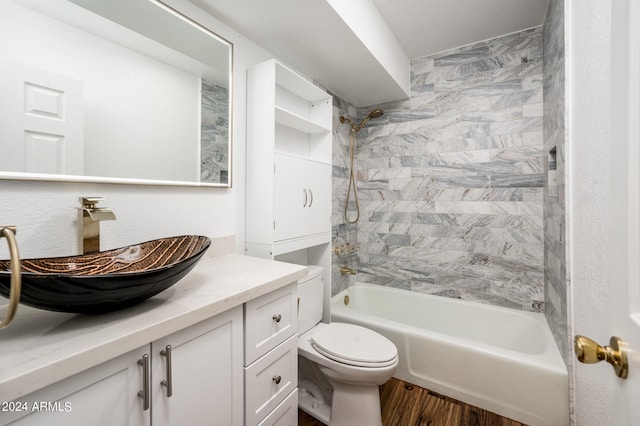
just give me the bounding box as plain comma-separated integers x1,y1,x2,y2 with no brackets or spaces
298,265,324,335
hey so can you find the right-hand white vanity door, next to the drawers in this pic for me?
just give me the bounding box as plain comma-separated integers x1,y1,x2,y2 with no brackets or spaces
151,306,243,426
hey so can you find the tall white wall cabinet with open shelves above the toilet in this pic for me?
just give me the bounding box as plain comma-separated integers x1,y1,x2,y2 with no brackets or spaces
246,60,333,258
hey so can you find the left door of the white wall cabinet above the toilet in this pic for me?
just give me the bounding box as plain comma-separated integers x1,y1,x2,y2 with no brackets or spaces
274,154,310,241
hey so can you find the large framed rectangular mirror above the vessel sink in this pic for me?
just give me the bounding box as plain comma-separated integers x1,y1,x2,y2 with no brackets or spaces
0,0,233,187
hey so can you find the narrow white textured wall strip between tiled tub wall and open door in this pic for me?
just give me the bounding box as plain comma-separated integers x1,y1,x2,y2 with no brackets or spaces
565,0,613,426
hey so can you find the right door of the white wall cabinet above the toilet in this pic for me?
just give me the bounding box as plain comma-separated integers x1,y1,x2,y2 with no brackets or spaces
306,161,331,235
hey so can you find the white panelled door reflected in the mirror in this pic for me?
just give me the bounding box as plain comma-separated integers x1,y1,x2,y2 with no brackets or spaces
0,61,84,175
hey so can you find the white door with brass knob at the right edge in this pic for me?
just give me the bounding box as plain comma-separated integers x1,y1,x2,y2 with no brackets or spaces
609,0,640,425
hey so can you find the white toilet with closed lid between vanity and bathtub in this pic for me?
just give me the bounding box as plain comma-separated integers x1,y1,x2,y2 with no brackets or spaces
298,266,398,426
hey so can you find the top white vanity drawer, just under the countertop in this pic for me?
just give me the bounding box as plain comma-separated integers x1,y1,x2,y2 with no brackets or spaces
244,283,298,365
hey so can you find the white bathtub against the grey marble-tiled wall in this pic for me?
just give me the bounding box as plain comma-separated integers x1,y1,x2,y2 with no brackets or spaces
331,283,569,426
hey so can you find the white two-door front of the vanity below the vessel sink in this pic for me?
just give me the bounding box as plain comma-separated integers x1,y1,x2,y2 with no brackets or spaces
0,306,243,426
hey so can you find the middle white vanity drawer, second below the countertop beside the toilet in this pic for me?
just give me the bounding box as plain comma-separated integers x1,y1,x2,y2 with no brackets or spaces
244,334,298,425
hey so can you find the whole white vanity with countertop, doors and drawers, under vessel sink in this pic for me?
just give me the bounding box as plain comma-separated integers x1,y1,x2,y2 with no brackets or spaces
0,254,306,426
